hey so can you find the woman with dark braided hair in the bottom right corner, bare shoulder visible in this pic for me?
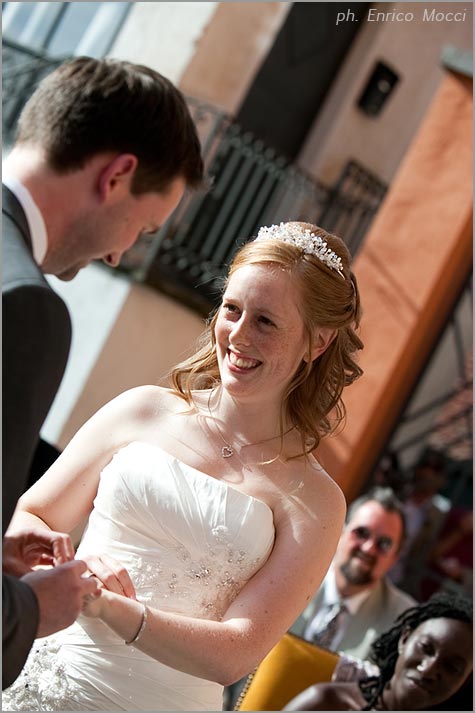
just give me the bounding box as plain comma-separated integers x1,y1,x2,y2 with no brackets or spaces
284,592,473,711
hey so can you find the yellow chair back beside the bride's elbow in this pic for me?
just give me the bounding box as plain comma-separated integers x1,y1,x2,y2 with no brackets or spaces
234,633,339,711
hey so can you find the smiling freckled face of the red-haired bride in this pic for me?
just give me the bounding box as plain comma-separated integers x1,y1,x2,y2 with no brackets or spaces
215,265,307,398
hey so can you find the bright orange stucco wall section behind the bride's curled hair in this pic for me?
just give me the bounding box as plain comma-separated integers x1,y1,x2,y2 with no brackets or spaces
318,73,473,499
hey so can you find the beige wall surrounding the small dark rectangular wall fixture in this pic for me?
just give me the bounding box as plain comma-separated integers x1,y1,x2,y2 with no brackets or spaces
298,2,472,184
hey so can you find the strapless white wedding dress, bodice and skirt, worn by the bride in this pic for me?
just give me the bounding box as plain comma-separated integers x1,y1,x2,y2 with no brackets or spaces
3,442,274,711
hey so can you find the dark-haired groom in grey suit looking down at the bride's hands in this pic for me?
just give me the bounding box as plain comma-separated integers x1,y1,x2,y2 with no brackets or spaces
2,52,203,688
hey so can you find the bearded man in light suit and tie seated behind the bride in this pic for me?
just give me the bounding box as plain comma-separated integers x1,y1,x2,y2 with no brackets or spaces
291,487,415,659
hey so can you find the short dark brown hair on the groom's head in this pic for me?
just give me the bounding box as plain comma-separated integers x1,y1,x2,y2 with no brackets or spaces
16,57,203,194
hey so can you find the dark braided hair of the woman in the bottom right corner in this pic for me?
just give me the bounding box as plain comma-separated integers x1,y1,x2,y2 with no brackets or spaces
359,592,473,711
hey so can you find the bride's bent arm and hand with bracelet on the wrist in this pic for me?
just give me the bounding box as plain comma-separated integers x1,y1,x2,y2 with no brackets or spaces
85,472,345,685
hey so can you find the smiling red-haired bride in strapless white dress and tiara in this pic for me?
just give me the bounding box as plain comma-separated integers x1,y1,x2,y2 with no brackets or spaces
3,223,362,711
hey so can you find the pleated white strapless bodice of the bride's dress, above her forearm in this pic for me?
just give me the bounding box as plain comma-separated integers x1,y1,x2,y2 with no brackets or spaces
78,442,274,619
